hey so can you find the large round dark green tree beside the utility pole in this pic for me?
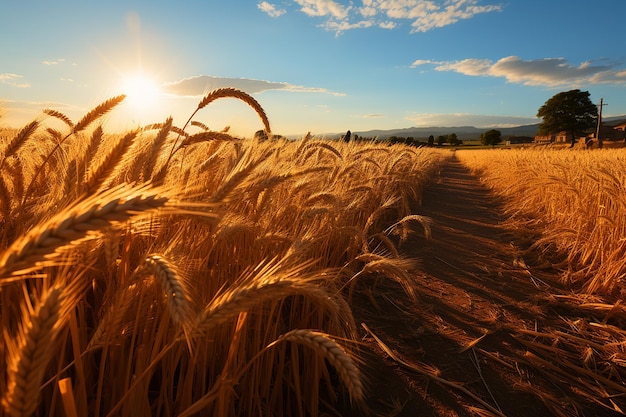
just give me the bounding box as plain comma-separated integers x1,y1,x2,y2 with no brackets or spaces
537,90,598,146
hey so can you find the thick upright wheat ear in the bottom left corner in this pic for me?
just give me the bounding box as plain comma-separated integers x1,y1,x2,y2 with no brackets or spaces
2,287,63,417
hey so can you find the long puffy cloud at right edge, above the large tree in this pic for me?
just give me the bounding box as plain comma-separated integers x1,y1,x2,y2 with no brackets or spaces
411,56,626,87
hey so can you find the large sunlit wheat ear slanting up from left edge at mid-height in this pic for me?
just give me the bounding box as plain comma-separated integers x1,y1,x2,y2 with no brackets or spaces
0,186,168,278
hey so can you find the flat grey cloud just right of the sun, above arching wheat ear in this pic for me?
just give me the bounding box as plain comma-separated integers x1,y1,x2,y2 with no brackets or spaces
162,75,344,97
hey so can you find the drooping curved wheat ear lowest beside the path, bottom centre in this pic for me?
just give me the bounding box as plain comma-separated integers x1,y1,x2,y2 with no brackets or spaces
272,329,364,405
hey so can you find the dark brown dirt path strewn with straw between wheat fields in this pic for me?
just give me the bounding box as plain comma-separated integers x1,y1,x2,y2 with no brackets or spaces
357,155,626,417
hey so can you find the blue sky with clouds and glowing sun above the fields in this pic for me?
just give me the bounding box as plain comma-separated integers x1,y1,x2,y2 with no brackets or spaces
0,0,626,136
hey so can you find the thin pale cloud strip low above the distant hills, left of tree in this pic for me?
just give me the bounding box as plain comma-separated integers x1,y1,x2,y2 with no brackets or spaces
406,113,539,128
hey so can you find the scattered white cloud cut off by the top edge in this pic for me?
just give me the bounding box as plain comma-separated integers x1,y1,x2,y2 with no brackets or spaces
257,0,502,34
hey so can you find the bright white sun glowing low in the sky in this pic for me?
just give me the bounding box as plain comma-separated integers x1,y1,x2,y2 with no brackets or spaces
121,73,162,121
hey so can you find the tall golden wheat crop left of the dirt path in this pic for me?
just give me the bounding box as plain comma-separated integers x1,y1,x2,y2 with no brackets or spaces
0,88,449,417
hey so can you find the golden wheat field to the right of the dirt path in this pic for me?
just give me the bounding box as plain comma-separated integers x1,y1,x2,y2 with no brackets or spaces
457,149,626,300
